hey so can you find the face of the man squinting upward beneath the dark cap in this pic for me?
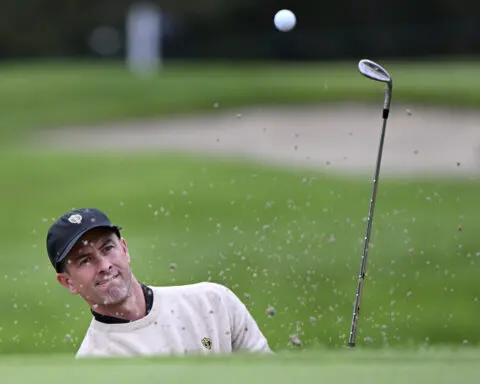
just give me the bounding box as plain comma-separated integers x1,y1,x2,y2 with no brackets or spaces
57,228,132,306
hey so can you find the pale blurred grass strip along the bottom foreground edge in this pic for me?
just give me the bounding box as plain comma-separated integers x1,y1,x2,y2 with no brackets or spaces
0,350,480,384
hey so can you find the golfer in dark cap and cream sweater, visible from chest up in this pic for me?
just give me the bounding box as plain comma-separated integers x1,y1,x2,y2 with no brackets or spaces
46,208,271,358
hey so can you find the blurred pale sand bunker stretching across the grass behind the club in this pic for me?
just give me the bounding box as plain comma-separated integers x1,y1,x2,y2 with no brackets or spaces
34,103,480,177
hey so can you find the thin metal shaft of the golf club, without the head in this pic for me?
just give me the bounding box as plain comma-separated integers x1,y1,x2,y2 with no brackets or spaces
348,103,390,347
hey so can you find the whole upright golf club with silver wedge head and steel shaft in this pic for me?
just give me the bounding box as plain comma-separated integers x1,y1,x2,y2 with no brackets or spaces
348,59,392,347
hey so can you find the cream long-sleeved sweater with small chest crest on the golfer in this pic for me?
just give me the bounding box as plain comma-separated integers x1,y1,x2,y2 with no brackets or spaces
77,282,271,358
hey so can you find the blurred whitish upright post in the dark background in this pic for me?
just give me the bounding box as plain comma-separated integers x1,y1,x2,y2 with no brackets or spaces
126,2,162,75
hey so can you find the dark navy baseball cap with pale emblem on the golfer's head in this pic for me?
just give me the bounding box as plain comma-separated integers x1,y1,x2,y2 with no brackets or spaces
47,208,122,272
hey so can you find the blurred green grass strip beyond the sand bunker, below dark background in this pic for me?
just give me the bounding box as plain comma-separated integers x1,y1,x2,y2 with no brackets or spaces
0,60,480,143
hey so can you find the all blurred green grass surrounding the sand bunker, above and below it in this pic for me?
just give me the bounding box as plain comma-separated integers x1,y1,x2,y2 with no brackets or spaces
0,61,480,354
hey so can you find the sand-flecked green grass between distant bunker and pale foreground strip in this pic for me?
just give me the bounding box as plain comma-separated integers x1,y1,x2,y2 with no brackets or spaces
0,150,480,356
